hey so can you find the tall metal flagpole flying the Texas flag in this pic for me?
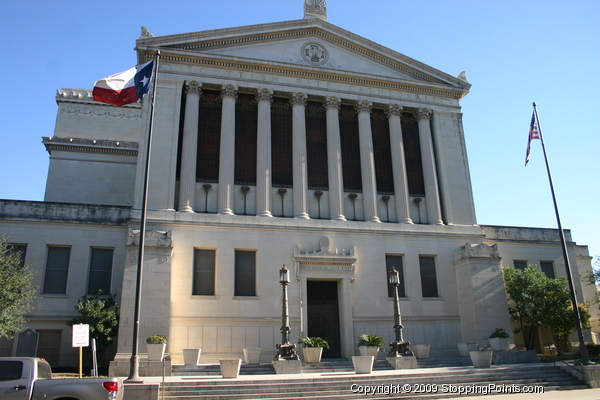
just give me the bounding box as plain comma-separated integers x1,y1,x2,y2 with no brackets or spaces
125,50,160,383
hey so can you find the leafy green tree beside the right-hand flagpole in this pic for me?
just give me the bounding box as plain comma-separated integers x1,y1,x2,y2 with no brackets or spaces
502,265,590,353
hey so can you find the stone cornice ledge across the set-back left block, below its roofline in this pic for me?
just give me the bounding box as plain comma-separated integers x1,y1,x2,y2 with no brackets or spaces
42,136,139,156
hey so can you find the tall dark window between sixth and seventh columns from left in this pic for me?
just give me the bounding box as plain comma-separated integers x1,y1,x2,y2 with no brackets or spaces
371,109,394,194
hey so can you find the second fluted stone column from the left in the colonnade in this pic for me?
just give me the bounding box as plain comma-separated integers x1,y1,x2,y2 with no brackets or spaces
217,85,237,215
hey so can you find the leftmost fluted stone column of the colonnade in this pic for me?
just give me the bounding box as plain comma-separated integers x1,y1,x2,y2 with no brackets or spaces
178,81,202,212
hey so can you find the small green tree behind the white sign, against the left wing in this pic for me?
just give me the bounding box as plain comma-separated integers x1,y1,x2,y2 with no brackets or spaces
67,290,120,349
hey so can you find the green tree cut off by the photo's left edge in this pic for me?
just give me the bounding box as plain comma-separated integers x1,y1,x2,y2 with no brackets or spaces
0,237,37,339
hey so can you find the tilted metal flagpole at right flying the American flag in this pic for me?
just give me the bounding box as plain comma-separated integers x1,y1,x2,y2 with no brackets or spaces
533,102,590,365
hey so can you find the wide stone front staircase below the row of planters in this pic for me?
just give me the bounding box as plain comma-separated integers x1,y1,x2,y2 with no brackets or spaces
163,360,587,400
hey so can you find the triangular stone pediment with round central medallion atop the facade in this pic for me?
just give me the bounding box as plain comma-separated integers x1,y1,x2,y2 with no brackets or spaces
137,19,470,98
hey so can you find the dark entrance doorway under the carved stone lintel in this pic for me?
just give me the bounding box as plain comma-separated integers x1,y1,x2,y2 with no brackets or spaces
306,281,342,358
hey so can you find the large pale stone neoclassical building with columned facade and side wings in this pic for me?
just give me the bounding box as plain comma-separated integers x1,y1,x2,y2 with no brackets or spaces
0,1,598,365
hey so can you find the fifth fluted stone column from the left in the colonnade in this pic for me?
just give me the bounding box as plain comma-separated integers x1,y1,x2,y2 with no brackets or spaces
324,96,346,221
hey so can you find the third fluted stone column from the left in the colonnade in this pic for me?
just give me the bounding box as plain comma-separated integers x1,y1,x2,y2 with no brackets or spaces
256,89,273,217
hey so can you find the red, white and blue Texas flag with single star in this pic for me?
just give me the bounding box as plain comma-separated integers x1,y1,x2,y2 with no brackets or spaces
92,60,154,106
